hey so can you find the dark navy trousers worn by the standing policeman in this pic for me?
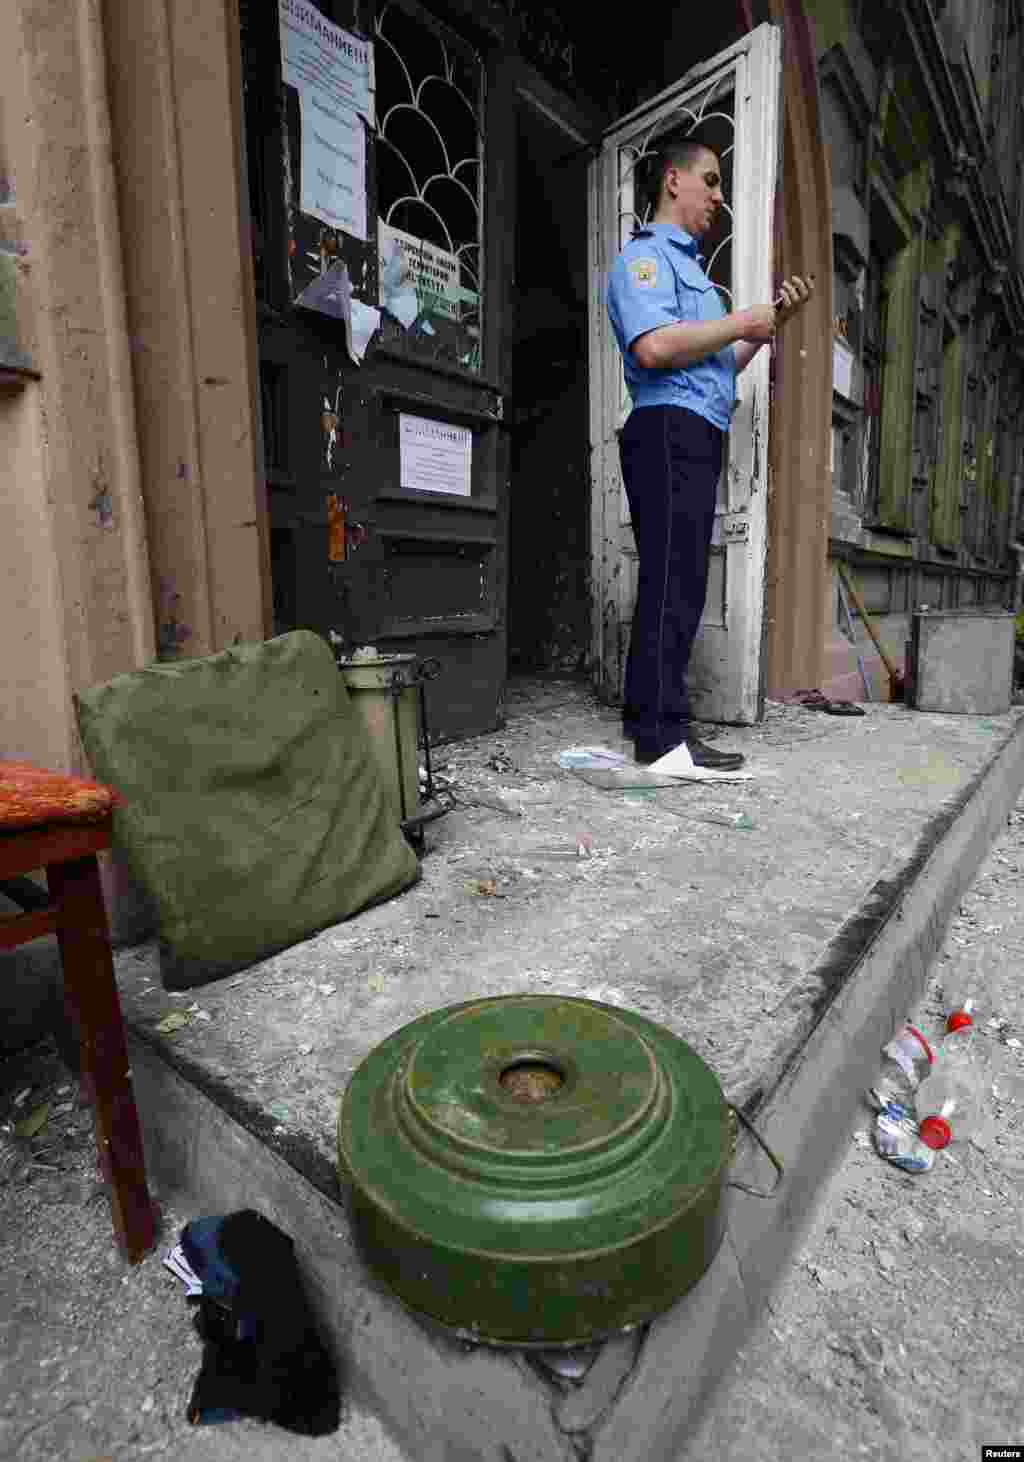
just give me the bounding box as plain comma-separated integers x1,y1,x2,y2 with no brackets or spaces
619,406,726,750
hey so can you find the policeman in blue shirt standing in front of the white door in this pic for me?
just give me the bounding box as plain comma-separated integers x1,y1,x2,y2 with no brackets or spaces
607,140,813,769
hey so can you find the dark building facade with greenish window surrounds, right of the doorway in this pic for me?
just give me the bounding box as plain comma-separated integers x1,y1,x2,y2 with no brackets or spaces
806,0,1024,689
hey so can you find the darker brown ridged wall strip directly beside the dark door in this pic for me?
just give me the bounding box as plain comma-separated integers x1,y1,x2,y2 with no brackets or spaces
107,0,271,656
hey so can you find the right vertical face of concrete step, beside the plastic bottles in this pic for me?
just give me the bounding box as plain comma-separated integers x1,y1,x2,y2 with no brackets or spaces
592,710,1024,1462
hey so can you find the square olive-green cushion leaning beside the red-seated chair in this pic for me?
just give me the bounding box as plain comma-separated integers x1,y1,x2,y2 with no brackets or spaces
76,630,418,990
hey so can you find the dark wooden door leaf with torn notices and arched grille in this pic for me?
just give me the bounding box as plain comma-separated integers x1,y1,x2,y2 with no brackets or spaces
241,0,513,738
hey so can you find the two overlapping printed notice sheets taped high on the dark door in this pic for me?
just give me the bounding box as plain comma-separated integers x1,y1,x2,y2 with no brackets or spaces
278,0,373,240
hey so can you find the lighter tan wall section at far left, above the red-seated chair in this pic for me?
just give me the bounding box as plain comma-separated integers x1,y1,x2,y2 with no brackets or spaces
0,0,154,768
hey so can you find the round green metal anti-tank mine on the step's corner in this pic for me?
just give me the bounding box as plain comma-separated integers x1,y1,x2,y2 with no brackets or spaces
338,996,736,1347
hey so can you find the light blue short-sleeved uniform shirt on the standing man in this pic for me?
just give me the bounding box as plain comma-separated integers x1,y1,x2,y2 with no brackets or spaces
607,224,736,431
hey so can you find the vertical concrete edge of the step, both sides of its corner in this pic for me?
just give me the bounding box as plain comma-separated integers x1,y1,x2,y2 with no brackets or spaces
130,701,1024,1462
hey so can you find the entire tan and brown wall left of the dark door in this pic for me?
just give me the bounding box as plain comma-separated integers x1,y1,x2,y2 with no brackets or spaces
0,0,269,768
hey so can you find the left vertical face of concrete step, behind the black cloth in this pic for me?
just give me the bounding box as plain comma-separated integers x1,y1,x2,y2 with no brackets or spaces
129,1035,578,1462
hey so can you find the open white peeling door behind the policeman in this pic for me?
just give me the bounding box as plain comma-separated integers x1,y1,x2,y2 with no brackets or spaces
590,23,783,724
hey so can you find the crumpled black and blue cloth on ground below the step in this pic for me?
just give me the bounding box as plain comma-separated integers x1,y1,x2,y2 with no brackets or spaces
181,1209,341,1437
